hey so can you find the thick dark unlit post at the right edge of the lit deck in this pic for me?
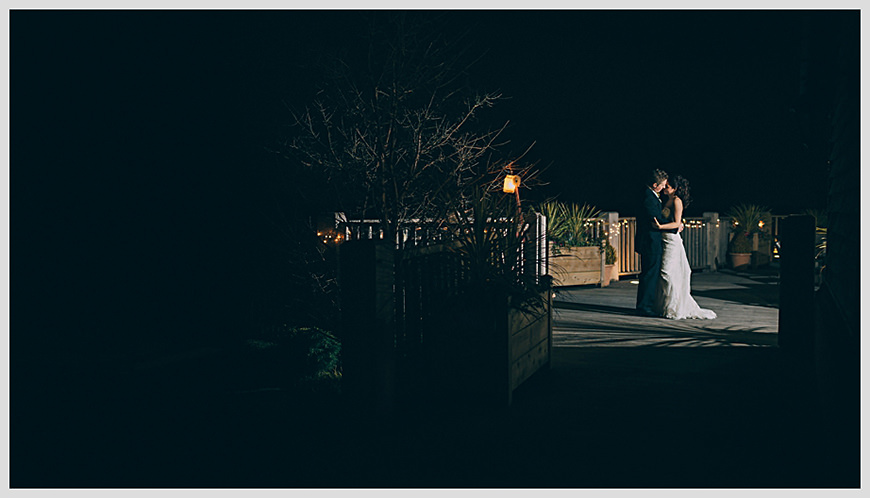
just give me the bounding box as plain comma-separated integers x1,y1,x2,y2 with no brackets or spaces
778,215,816,356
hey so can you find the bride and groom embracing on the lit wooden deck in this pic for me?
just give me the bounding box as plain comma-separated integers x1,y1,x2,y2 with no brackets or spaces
634,169,716,320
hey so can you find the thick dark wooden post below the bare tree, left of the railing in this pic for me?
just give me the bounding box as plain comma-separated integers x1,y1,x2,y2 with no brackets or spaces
338,240,396,412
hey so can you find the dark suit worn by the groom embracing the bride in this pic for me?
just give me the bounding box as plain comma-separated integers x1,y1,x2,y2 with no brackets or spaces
634,187,665,315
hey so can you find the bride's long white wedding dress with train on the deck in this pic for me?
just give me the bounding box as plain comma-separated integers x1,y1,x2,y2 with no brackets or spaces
655,229,716,320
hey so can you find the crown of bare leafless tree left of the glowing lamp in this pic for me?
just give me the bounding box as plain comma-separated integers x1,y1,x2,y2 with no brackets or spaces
284,15,540,248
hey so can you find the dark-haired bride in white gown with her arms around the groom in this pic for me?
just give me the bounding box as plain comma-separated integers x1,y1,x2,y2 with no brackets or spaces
653,176,716,320
